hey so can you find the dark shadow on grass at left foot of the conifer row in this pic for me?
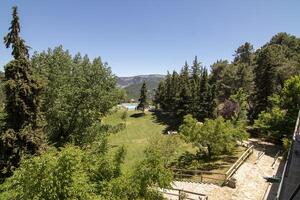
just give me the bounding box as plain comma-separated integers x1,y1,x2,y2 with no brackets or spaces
152,110,181,133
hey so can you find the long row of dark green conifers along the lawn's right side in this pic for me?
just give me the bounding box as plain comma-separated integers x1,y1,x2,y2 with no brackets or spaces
153,33,300,140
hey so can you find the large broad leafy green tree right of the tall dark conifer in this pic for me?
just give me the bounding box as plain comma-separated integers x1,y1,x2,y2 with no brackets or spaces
31,47,119,146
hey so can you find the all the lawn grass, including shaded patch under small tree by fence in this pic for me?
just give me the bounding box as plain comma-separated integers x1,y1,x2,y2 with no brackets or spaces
103,110,245,178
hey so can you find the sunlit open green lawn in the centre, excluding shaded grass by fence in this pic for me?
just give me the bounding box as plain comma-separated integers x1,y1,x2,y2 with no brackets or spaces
103,111,193,170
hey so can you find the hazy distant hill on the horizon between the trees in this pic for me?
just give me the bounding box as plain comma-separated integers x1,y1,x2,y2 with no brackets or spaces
117,74,165,100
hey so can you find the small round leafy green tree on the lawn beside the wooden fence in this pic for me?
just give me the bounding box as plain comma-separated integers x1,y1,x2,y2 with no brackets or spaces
179,115,247,158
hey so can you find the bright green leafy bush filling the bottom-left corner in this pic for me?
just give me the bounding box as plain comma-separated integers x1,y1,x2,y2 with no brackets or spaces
0,146,98,200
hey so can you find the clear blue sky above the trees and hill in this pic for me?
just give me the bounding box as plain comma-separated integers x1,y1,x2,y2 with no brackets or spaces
0,0,300,76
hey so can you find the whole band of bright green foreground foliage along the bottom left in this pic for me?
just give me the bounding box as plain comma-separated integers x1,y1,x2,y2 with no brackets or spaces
0,139,172,200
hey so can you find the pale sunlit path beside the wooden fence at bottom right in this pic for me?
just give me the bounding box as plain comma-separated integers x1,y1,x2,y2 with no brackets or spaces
165,142,279,200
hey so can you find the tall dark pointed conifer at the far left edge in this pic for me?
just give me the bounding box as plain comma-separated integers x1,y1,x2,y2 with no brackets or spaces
0,7,44,178
